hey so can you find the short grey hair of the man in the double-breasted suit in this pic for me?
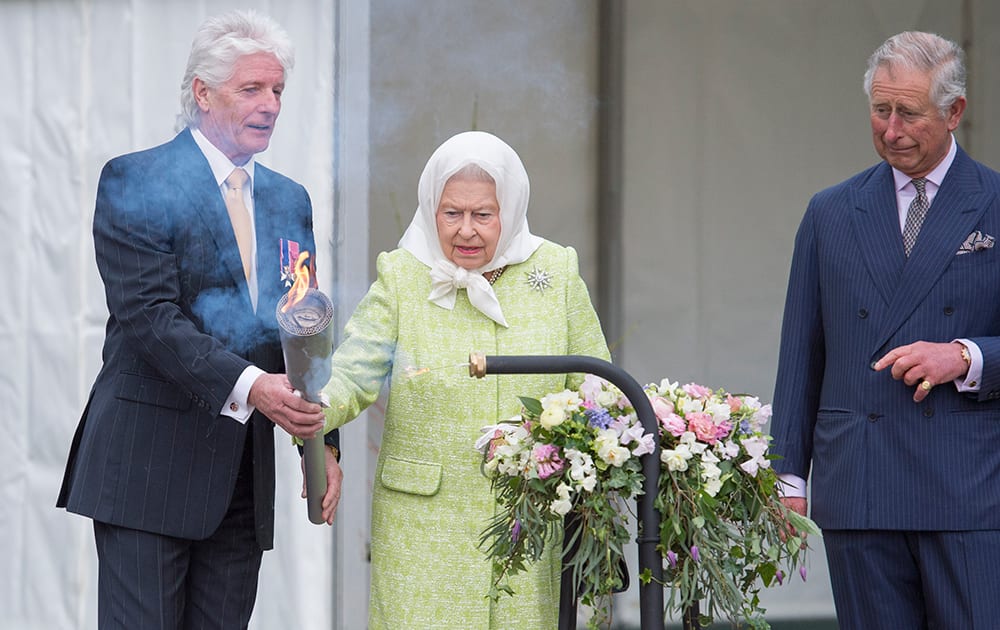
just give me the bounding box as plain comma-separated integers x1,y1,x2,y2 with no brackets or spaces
864,31,965,116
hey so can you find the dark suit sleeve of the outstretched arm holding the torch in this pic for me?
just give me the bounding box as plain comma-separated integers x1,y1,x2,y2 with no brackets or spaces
94,160,249,410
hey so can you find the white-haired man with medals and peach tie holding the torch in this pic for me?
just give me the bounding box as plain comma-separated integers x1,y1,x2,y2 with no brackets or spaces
58,12,341,630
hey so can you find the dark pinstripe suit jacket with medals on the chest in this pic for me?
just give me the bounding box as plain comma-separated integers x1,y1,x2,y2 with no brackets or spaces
57,130,315,549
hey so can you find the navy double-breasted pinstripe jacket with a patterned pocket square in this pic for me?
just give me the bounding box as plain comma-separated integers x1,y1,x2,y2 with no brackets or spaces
772,148,1000,530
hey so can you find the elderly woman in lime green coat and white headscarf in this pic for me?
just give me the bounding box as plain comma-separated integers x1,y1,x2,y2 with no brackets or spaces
325,132,609,630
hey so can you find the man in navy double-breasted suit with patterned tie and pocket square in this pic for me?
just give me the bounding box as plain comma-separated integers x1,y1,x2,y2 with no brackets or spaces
772,32,1000,630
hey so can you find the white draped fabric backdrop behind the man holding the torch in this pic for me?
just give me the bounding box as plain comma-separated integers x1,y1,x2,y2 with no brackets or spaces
0,0,334,630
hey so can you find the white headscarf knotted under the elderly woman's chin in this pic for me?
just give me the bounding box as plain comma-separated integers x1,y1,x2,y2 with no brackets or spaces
399,131,542,327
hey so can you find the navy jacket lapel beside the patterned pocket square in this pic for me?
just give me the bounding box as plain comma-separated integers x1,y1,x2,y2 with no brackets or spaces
878,148,994,356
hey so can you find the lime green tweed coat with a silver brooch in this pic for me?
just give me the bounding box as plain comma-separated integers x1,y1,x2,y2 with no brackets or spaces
326,241,609,630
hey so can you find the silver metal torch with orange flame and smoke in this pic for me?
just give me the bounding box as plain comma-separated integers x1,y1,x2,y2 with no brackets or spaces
275,252,333,524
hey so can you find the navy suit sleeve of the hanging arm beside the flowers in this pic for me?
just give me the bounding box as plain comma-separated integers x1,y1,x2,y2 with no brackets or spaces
771,200,826,479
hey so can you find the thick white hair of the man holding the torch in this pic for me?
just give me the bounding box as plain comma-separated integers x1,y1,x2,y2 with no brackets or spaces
177,9,295,131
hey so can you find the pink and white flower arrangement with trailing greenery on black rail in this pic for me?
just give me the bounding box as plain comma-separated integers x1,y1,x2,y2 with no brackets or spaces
476,376,819,628
